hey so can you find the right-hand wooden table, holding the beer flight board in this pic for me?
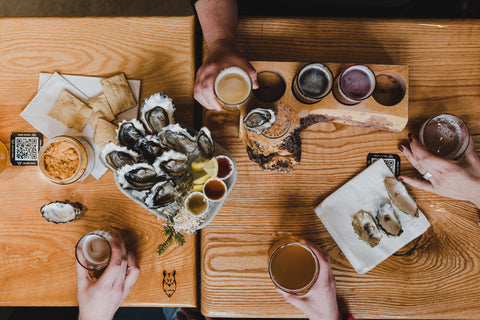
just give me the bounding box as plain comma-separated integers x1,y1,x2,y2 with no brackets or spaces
201,18,480,319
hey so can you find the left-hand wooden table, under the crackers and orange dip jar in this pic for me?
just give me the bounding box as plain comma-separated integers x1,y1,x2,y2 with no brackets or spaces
0,16,197,307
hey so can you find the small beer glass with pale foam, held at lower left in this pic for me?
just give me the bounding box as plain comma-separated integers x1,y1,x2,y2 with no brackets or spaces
75,230,113,271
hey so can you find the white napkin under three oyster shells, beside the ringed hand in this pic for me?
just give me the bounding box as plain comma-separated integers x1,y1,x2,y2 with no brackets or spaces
315,159,430,274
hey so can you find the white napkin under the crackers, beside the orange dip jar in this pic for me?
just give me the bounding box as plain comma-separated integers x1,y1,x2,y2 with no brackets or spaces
20,73,141,179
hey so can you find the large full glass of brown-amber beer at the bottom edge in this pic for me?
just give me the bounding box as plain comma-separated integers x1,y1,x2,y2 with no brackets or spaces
268,242,319,295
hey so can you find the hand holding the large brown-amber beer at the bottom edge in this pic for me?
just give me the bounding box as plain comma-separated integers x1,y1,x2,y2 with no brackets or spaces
277,239,341,320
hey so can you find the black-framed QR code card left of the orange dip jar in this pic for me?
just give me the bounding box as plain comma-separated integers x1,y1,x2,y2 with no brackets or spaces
10,132,43,166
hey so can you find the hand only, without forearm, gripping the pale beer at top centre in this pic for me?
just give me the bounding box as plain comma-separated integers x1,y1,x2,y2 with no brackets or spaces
193,40,258,111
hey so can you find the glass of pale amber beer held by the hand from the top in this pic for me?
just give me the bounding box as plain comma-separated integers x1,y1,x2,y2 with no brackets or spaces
214,67,252,111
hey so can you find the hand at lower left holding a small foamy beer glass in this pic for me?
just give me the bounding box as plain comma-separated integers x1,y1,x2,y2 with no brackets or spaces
76,231,140,320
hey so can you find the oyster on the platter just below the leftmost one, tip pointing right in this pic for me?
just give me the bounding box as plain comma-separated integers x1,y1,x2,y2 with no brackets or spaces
117,163,165,190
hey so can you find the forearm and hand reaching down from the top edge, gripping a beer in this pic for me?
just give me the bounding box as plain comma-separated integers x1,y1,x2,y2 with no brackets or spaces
194,0,258,111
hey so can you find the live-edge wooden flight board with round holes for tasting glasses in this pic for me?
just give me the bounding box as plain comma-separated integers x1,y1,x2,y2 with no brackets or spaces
247,61,409,131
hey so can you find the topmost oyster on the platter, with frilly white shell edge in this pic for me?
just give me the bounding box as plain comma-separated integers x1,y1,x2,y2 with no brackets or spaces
140,93,175,134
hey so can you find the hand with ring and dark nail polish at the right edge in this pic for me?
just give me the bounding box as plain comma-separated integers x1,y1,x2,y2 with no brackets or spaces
398,133,480,208
